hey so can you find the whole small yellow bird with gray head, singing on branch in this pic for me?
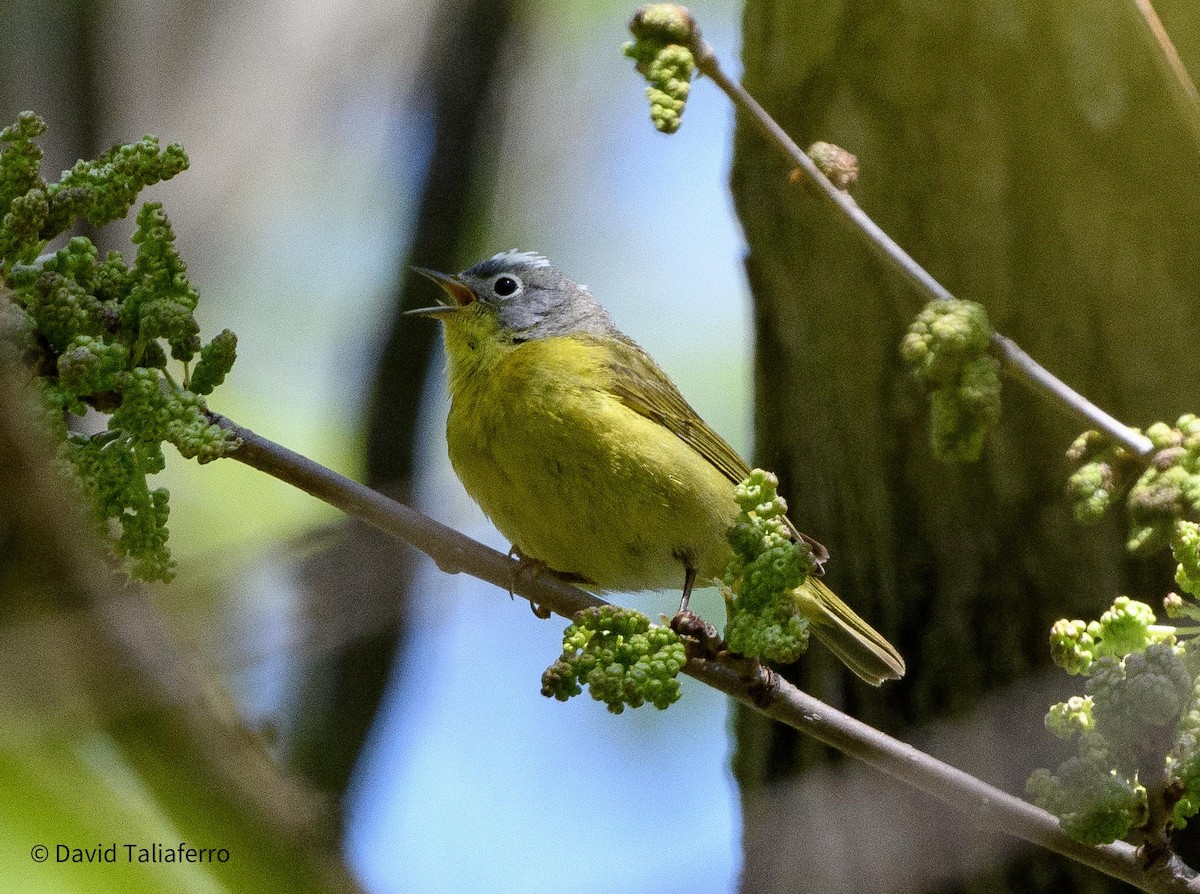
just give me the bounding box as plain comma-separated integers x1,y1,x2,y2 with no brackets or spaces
409,250,905,685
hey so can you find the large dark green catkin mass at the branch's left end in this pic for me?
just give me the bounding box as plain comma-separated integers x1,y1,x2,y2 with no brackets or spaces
0,113,239,580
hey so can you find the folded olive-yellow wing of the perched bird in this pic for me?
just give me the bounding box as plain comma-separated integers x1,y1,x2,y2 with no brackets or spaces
595,338,829,564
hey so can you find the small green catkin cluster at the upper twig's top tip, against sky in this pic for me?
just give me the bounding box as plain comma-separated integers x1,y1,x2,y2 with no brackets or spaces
622,4,696,133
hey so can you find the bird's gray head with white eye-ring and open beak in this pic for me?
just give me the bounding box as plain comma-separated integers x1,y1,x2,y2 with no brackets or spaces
413,248,617,341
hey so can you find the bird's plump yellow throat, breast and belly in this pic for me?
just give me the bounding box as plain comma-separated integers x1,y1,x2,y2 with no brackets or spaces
446,314,737,590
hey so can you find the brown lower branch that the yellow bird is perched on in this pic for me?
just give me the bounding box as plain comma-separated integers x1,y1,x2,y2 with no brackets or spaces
212,414,1200,894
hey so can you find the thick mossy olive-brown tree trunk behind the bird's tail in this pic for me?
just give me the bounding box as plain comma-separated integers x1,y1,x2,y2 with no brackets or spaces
732,0,1200,892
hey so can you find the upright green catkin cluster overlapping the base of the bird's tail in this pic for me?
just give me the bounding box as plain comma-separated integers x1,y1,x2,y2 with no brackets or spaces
721,469,814,664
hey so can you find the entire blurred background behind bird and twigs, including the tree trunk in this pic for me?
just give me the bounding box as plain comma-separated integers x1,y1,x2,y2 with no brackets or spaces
7,0,1200,894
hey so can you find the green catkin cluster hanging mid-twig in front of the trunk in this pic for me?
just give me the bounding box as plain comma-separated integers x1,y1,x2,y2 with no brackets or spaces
900,299,1000,462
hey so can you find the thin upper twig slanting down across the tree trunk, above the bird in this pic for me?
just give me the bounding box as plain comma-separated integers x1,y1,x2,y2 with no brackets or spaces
692,37,1154,460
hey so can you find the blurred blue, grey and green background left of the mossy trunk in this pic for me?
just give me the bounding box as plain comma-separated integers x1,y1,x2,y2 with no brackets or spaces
0,0,751,893
